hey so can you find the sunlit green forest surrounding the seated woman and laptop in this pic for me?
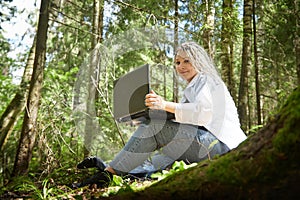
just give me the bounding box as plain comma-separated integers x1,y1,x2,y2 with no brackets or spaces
0,0,300,199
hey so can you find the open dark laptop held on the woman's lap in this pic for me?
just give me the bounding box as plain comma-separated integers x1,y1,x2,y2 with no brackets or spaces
113,64,175,123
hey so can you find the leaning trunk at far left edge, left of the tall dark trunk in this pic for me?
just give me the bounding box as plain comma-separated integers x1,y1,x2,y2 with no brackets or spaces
0,37,36,151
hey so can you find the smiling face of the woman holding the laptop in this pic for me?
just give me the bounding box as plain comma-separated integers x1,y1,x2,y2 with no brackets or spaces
175,52,197,82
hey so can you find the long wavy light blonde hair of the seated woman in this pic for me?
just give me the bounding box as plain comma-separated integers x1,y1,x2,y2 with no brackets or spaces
175,42,220,80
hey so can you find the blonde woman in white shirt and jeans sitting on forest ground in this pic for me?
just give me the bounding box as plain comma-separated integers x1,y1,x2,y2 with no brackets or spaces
72,42,246,187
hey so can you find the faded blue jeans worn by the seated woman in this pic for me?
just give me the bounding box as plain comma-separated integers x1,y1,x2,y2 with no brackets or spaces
109,120,229,175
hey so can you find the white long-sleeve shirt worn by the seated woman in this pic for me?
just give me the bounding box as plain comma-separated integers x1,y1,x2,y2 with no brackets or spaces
175,73,247,149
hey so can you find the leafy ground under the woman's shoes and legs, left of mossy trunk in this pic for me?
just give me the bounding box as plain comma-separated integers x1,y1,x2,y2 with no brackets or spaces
0,161,192,200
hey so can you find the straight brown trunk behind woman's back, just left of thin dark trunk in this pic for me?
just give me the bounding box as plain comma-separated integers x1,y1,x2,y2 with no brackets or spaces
238,0,252,131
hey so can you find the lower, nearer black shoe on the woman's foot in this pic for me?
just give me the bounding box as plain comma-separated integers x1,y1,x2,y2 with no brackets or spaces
72,171,113,189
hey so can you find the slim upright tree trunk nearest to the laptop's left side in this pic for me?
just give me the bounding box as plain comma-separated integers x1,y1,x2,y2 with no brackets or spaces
84,0,104,157
